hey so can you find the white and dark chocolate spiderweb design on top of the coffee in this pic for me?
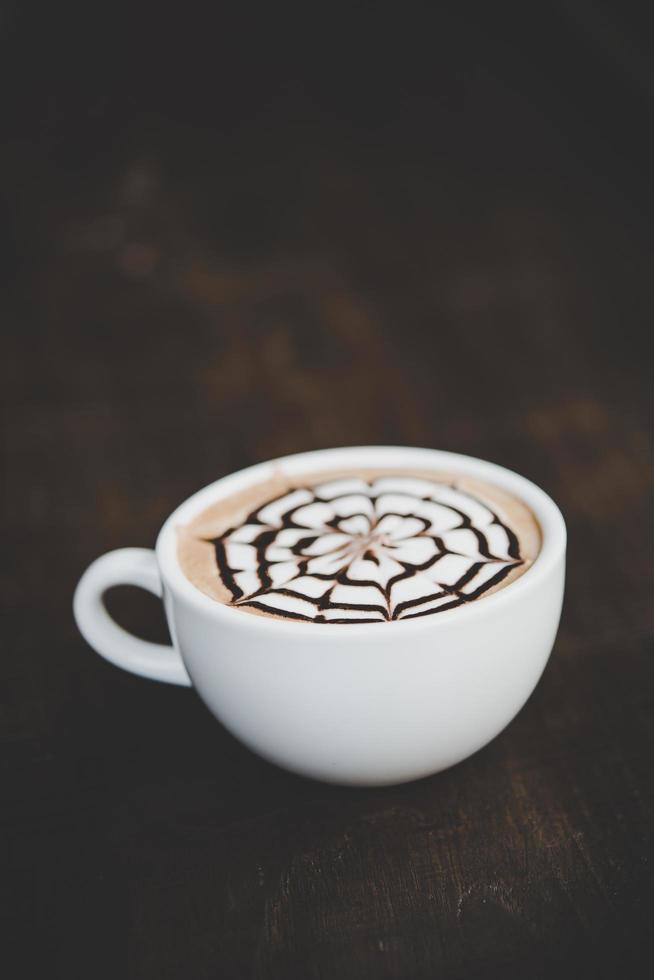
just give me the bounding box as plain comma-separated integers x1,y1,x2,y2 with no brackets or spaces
210,476,523,623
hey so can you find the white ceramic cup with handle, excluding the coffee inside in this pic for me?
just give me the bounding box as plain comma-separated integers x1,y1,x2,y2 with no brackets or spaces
74,446,566,786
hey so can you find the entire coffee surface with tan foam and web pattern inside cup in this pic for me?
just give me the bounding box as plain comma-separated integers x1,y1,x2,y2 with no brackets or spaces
178,469,541,624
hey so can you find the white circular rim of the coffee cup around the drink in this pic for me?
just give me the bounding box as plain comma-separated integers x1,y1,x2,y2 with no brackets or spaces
155,446,566,639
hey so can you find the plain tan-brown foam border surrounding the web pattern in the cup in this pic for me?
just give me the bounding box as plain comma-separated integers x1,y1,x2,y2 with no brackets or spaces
176,467,542,625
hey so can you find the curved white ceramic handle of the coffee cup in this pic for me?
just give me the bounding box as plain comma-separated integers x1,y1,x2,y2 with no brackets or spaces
73,548,191,687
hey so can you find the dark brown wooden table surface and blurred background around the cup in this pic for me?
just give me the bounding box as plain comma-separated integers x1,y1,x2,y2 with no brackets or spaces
0,0,654,980
